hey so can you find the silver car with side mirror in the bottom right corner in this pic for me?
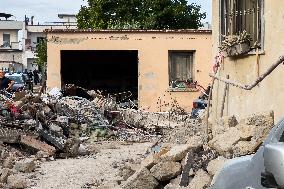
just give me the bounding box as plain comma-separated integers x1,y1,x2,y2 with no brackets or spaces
210,118,284,189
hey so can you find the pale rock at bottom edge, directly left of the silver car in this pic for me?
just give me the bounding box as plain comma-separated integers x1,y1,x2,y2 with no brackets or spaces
187,169,211,189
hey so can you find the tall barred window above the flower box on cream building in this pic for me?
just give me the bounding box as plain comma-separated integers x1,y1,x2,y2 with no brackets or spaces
220,0,263,47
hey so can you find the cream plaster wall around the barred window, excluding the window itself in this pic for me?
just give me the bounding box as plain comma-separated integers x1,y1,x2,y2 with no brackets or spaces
211,0,284,121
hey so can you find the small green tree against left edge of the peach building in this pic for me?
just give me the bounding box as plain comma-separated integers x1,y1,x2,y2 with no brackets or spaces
35,39,47,70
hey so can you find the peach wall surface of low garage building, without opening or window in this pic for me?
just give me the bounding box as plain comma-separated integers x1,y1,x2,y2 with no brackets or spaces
47,31,212,111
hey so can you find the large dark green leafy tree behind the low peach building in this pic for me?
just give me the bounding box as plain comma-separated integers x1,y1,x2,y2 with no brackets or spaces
77,0,206,29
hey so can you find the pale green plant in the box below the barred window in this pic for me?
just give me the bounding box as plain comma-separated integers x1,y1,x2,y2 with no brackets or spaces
220,30,252,51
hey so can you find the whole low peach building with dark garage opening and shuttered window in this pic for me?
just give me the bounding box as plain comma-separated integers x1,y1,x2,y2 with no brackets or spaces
47,30,212,111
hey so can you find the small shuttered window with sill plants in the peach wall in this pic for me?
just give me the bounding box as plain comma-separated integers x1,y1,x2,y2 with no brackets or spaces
169,51,194,88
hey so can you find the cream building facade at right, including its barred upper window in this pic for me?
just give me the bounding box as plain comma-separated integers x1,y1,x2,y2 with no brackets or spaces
211,0,284,121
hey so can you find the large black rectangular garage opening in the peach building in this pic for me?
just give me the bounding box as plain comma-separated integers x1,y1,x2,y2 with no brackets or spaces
61,50,138,100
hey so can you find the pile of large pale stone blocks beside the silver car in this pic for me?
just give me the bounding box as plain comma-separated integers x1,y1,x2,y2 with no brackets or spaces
116,112,274,189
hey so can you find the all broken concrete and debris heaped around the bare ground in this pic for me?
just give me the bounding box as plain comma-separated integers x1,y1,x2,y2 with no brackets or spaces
0,84,274,189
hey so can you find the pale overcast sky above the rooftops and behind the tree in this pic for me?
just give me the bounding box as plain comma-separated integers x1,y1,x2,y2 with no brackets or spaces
0,0,211,23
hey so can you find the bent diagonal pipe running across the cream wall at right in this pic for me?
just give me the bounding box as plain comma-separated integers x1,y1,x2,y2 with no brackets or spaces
209,56,284,90
